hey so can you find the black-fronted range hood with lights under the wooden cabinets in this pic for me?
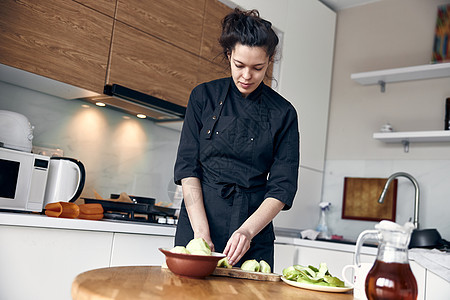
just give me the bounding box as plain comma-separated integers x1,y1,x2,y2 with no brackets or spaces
82,84,186,122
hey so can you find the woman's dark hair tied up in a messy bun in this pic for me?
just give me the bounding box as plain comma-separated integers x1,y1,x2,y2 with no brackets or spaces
219,8,279,59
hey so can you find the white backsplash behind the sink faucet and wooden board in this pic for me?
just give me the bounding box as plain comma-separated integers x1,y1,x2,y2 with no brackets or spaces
322,159,450,240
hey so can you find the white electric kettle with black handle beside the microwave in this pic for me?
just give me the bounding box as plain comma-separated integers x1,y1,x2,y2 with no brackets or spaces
44,157,86,207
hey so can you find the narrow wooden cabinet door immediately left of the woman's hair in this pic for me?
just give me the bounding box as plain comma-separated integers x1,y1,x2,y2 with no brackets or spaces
200,0,233,65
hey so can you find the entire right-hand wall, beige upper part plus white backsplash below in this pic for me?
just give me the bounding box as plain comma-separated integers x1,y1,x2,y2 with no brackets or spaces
323,0,450,239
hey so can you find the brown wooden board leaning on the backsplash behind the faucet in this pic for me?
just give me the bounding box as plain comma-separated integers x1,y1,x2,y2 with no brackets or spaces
342,177,397,222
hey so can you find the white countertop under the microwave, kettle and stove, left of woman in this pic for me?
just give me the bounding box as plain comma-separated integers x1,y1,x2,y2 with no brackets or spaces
0,212,176,236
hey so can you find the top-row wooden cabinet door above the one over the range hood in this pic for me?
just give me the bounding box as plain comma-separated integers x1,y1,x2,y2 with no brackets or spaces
116,0,205,55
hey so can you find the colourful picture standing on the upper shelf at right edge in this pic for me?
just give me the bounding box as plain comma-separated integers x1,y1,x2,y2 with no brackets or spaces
432,4,450,63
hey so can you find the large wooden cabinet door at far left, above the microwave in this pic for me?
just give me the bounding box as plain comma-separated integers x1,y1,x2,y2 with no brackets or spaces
0,0,113,93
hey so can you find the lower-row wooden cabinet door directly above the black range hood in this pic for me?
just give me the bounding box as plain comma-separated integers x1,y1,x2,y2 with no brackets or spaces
108,22,200,106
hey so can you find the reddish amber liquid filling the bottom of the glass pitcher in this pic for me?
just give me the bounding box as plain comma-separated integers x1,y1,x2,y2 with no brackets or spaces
366,260,417,300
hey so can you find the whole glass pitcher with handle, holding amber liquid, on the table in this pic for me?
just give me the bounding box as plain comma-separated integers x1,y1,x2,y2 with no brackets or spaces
355,220,417,300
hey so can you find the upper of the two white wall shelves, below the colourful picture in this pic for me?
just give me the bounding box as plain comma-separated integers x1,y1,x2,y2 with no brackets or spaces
350,63,450,92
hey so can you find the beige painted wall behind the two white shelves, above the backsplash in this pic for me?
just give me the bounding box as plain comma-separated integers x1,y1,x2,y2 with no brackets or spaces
327,0,450,159
